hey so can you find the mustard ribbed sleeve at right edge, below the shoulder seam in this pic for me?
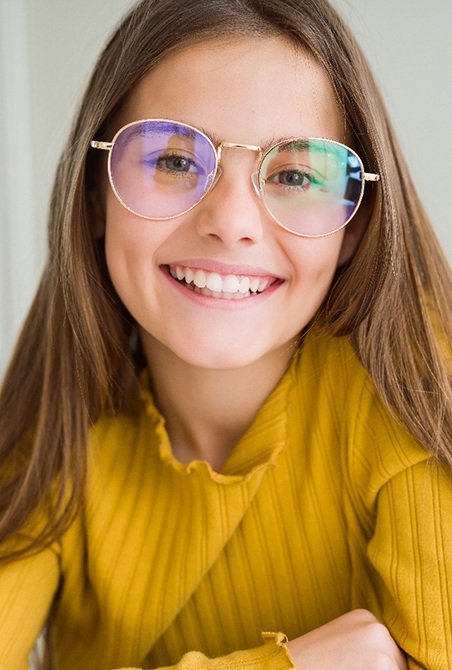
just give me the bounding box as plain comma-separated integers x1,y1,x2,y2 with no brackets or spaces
368,461,452,670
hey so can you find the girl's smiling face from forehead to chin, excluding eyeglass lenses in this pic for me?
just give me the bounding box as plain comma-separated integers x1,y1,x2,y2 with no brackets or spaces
106,37,364,369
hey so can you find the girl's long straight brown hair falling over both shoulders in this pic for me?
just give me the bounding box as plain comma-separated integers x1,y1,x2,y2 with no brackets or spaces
0,0,452,559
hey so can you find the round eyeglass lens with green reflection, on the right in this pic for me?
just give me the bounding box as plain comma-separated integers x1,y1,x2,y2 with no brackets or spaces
259,138,363,237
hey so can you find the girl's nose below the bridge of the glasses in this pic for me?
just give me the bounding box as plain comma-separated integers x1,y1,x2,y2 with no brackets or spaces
193,160,266,248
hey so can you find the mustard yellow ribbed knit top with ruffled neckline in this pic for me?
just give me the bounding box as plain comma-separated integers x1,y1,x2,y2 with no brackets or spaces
0,330,452,670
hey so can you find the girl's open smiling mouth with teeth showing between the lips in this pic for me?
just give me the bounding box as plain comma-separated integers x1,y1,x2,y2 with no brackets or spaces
167,265,280,300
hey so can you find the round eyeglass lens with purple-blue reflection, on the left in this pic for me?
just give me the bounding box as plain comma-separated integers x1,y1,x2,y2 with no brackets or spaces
109,120,216,219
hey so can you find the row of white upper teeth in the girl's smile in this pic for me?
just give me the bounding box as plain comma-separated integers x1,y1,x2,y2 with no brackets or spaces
169,265,270,293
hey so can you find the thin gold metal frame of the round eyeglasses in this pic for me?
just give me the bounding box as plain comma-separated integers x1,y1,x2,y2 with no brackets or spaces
90,118,380,238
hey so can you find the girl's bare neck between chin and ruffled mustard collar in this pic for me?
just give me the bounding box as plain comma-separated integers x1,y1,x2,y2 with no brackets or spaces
140,337,295,471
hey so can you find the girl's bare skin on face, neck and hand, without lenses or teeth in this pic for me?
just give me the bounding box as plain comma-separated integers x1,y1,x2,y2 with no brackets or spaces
98,37,406,670
